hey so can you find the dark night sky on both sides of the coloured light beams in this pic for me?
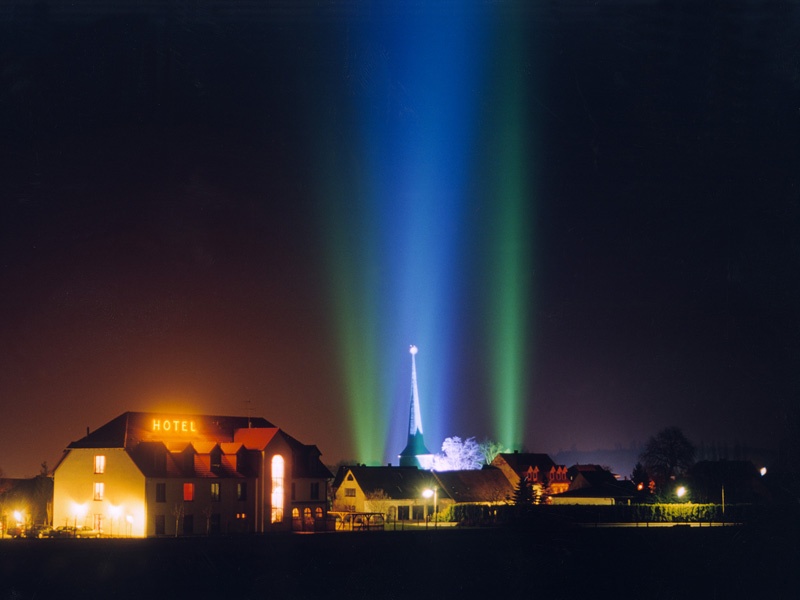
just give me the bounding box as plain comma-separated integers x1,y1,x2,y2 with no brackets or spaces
0,0,800,477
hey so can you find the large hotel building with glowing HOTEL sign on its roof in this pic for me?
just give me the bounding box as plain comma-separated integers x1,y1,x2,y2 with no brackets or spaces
53,412,332,537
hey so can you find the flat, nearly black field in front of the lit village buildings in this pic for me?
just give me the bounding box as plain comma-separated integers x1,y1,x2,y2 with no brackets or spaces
0,524,800,600
